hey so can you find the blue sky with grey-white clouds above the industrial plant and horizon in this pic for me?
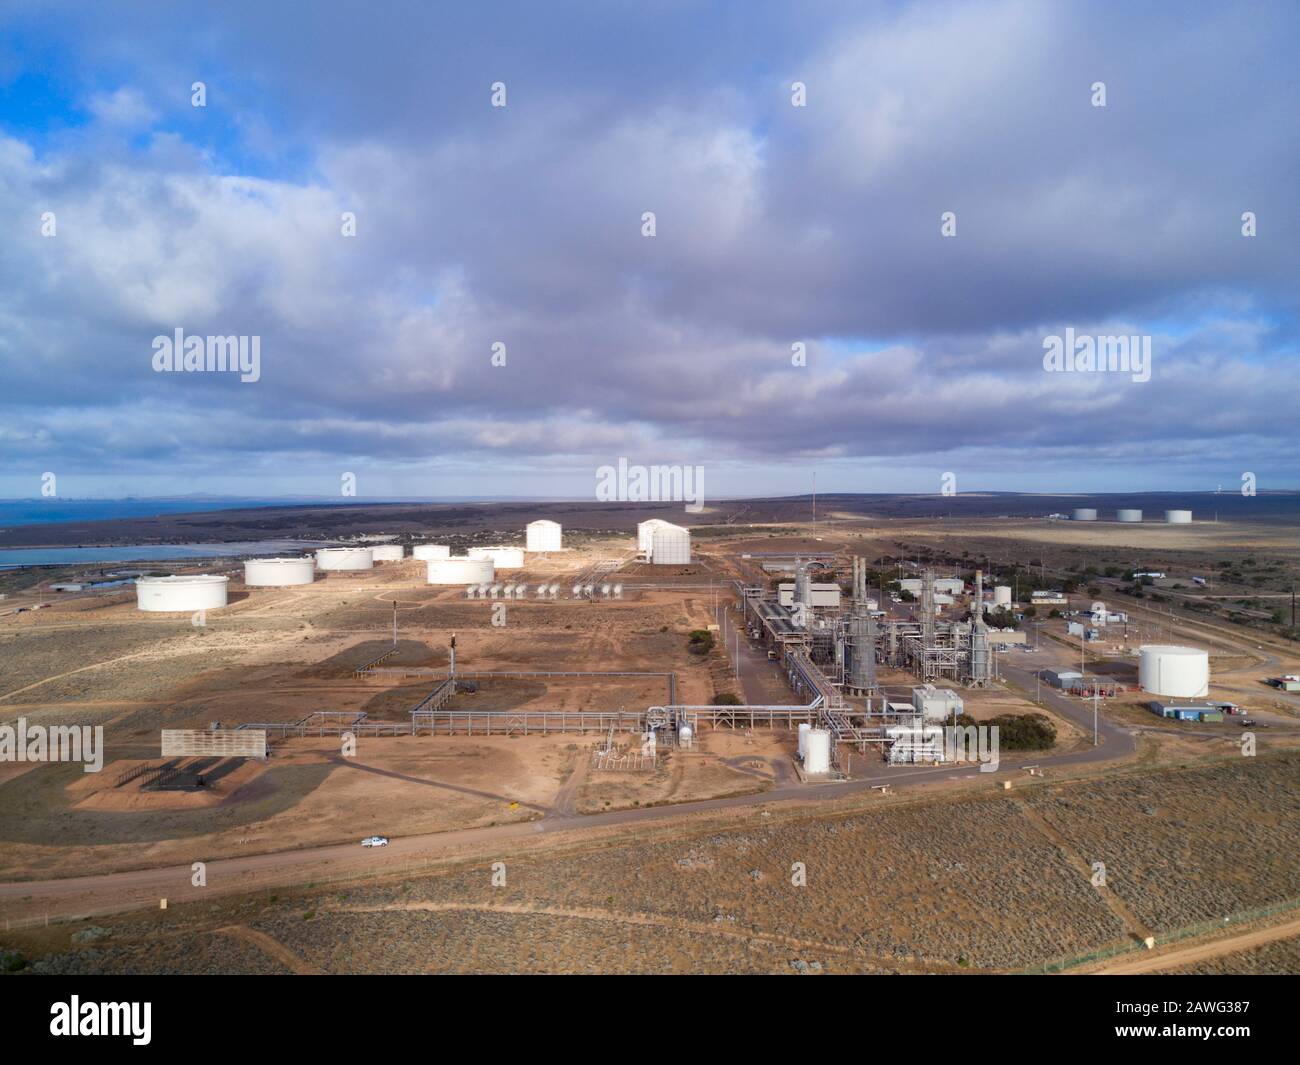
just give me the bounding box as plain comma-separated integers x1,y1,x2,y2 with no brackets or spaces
0,0,1300,497
